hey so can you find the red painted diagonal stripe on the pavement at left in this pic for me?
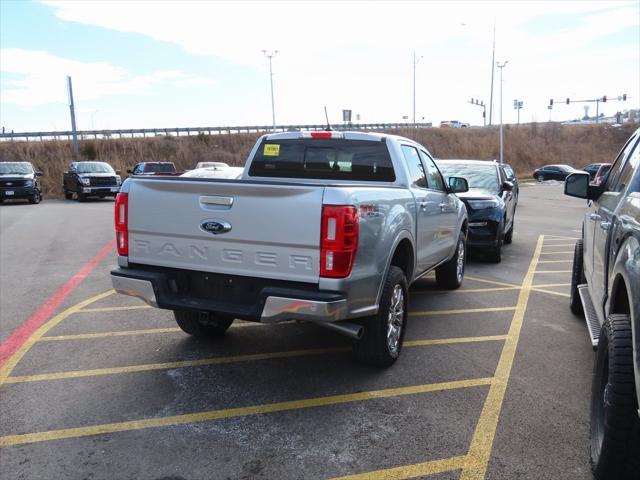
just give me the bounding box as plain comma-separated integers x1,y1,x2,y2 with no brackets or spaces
0,240,116,367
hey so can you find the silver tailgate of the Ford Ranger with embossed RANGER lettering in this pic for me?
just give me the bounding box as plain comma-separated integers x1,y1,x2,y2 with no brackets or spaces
129,178,324,283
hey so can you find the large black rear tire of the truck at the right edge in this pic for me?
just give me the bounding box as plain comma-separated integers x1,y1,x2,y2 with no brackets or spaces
589,314,640,480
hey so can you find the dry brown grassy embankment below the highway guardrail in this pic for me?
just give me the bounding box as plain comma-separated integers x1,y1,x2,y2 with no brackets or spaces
0,124,636,198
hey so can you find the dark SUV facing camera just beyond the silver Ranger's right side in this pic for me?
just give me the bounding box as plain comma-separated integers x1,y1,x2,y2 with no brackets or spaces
438,160,517,263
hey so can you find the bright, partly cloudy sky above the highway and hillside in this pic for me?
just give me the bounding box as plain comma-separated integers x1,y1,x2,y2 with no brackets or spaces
0,0,640,132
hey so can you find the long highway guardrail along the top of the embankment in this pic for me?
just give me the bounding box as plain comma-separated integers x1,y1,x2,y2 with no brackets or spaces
0,123,431,141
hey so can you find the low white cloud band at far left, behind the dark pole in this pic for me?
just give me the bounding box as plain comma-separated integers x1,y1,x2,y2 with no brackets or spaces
0,48,211,106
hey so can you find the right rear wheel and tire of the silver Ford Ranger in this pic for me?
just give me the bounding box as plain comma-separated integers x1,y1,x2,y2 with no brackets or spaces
353,265,409,368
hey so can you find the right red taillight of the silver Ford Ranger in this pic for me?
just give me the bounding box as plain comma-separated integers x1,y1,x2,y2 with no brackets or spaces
320,205,358,278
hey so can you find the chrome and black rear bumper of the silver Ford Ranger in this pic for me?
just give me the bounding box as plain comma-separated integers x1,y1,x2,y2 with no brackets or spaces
111,268,348,323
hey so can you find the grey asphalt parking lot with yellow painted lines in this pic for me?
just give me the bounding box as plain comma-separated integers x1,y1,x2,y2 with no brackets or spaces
0,184,593,480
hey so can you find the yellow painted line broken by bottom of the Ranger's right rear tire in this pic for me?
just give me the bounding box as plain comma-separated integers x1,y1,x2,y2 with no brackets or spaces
5,335,506,384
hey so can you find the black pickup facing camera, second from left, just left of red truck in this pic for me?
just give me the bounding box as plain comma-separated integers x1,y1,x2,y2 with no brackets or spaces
62,162,122,201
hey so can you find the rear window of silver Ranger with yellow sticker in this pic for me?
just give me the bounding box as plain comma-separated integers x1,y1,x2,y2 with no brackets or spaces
249,138,396,182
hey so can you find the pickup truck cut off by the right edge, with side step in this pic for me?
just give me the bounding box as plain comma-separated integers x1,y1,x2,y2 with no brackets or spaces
565,129,640,480
